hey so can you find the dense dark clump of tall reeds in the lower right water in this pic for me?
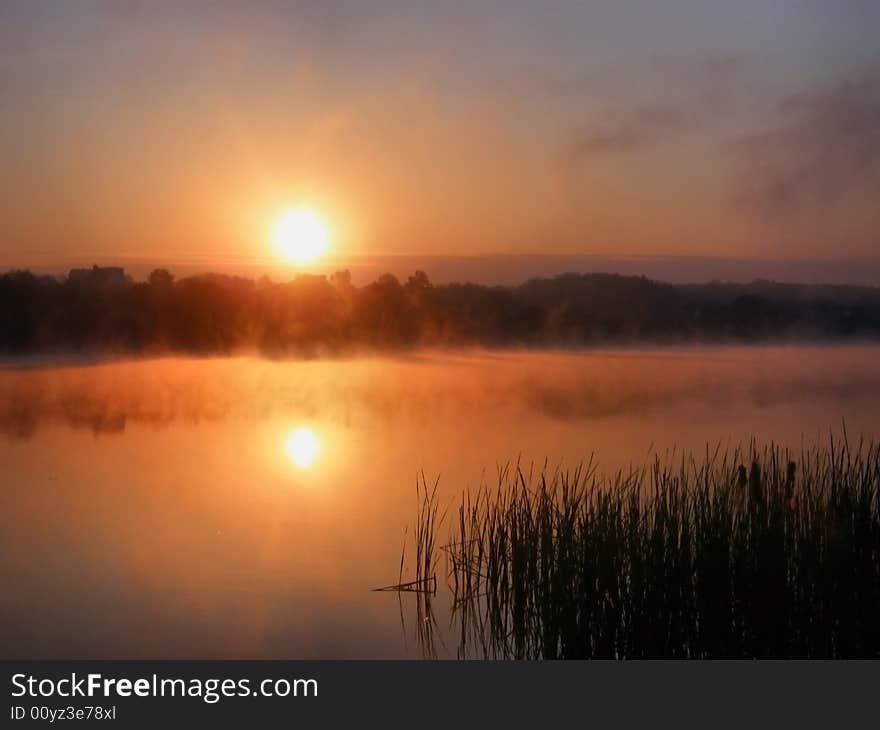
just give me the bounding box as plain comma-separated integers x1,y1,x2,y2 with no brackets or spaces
422,441,880,659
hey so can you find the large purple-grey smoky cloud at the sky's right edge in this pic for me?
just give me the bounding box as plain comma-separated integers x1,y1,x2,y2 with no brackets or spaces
734,73,880,217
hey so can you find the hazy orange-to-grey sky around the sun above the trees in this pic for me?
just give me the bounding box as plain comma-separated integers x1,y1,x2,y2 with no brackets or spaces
0,0,880,276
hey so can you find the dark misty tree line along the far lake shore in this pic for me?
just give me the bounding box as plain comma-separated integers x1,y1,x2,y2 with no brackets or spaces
0,267,880,356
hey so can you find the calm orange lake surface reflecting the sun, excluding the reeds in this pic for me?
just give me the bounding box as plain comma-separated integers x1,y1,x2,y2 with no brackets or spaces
0,345,880,659
